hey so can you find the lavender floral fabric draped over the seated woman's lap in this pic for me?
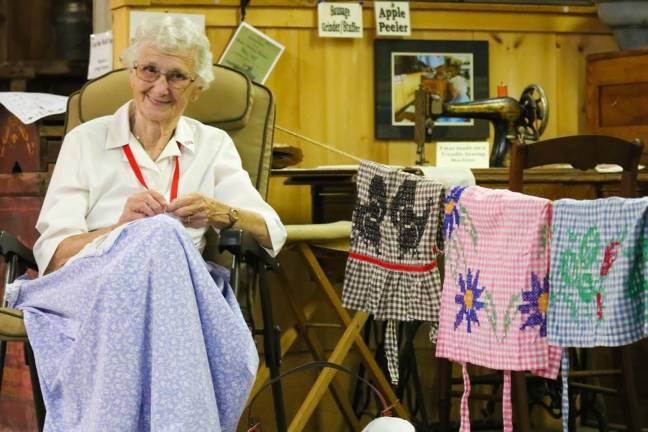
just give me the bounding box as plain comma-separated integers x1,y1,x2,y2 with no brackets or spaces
9,215,258,432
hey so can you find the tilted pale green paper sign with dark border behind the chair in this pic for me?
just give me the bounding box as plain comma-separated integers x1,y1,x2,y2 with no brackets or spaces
218,21,284,84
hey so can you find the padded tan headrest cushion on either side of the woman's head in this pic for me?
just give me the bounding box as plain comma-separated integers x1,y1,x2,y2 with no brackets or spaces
74,65,252,130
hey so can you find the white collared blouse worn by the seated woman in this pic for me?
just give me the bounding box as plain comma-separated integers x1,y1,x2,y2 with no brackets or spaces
34,102,286,274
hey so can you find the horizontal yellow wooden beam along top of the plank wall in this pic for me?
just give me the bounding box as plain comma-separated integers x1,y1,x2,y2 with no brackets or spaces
111,0,610,34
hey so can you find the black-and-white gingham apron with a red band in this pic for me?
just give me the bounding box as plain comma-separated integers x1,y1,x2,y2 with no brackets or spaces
342,161,443,383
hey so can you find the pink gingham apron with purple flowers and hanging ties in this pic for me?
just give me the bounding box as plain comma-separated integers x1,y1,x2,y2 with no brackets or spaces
436,186,561,431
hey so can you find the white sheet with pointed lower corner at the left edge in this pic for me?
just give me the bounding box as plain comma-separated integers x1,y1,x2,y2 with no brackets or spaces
0,92,68,124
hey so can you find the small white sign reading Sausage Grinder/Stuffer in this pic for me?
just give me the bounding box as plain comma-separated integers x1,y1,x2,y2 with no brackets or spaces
317,2,362,38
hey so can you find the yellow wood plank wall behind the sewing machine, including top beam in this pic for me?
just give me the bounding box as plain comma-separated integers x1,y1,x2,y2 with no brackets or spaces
111,0,618,223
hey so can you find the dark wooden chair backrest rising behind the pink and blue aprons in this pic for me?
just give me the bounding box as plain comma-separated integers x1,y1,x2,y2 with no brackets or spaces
509,135,643,198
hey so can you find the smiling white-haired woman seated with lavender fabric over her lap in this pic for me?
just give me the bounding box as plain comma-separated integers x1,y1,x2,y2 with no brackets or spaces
8,17,285,432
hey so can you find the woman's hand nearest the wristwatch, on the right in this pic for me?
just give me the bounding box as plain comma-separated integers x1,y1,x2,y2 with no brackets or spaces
167,192,229,228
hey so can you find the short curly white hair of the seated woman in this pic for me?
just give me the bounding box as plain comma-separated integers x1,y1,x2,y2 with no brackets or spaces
121,15,214,90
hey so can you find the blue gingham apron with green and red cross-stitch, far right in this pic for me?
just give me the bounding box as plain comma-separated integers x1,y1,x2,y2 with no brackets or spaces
547,198,648,432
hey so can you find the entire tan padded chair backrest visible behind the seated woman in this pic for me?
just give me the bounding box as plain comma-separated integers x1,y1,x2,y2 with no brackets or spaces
65,65,275,198
